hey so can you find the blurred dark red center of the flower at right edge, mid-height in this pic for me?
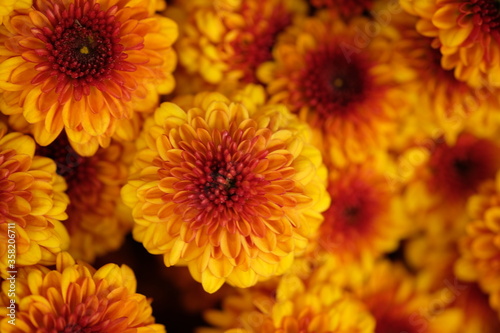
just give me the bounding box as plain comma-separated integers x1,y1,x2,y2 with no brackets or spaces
429,135,500,199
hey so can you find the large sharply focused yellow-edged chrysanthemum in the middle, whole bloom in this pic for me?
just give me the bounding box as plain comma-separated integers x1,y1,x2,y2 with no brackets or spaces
122,93,329,292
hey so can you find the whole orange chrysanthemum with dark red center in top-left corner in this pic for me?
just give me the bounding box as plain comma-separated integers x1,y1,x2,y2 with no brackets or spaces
0,0,177,156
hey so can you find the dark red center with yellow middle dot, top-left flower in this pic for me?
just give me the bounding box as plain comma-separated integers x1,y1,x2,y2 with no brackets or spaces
31,0,144,103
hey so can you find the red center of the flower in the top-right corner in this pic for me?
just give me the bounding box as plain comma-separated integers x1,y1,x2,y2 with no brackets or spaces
458,0,500,45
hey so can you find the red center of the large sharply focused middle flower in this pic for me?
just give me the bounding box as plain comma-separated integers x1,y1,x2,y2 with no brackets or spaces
174,130,269,224
